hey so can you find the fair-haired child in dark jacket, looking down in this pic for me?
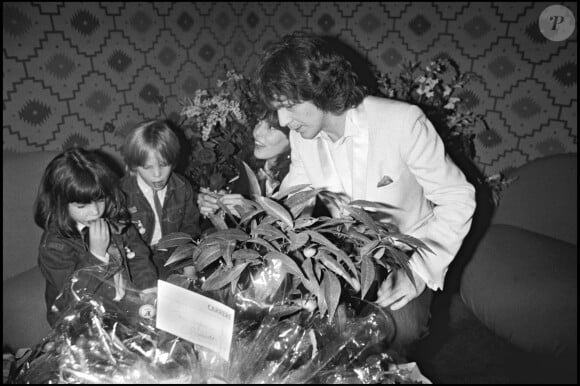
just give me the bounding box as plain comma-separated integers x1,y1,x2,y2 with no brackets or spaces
121,121,200,279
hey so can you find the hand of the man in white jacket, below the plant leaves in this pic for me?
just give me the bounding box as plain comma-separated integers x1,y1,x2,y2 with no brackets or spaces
375,269,426,311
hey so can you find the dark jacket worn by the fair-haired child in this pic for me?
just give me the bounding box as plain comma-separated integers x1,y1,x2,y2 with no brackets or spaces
121,172,200,245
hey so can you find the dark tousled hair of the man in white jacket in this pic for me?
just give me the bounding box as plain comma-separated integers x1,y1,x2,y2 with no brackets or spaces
256,31,367,114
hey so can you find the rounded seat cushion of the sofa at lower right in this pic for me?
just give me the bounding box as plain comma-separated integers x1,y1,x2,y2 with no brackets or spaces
460,225,578,356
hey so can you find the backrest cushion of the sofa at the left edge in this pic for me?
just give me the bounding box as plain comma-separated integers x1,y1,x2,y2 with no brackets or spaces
2,151,59,280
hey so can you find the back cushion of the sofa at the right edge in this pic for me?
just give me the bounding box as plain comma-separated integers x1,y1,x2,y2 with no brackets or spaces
492,153,578,244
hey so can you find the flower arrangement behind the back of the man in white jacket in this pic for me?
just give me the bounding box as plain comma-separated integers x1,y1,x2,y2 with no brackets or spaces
376,58,510,205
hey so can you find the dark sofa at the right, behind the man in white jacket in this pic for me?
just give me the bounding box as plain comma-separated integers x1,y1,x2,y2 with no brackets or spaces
460,154,578,367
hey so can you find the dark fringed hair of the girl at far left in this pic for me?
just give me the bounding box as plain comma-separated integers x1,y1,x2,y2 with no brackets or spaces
34,148,130,237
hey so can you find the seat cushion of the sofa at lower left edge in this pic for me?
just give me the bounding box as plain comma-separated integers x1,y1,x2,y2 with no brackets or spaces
2,267,50,351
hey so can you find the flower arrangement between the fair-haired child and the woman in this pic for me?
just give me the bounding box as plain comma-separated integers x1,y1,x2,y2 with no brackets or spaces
179,70,257,191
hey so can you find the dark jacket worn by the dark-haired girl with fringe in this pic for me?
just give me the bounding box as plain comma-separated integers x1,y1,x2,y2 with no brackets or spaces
38,220,157,326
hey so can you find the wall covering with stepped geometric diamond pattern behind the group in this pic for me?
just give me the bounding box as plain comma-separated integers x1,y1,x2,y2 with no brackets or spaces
2,2,578,175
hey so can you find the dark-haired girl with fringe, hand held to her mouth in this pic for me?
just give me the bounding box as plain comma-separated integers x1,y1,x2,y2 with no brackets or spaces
34,148,157,327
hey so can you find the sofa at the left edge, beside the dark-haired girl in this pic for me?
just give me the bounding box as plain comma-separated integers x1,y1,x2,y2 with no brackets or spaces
2,151,122,352
